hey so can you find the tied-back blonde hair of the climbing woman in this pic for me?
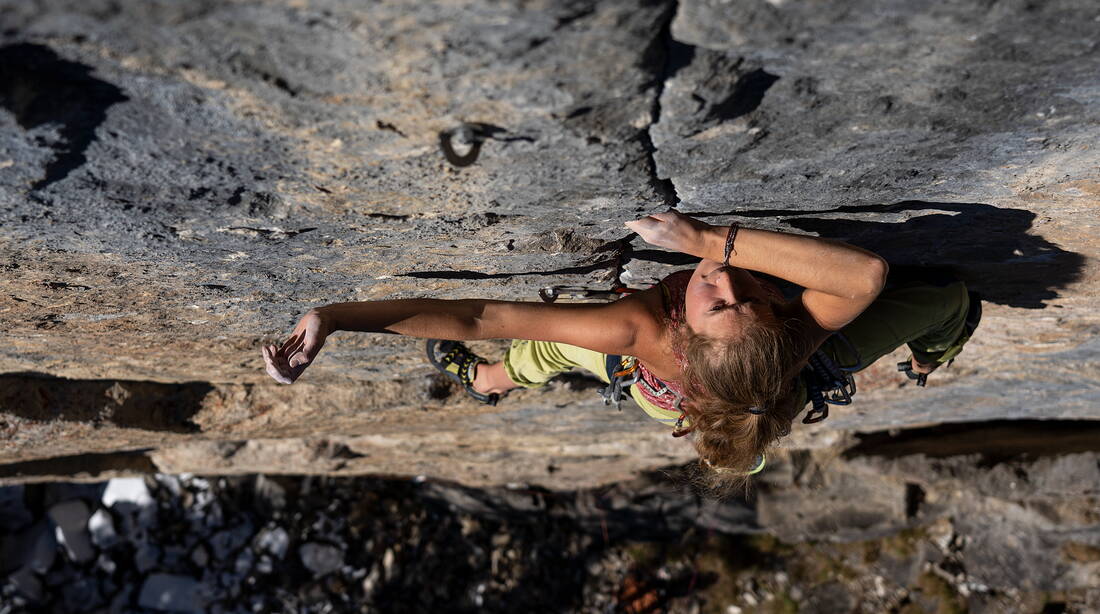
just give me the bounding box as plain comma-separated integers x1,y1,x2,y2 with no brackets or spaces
678,316,810,495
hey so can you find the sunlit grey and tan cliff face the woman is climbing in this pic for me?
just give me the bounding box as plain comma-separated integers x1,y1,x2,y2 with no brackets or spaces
0,0,1100,487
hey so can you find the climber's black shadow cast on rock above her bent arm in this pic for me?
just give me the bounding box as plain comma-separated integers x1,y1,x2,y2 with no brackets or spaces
737,200,1085,309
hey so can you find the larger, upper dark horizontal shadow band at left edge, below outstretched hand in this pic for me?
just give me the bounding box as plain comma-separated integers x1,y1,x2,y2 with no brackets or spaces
0,373,206,432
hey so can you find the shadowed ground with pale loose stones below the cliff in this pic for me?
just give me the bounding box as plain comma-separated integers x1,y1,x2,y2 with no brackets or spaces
0,474,1100,614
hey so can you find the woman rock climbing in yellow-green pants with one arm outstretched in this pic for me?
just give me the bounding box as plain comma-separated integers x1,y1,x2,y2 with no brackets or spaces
263,211,980,492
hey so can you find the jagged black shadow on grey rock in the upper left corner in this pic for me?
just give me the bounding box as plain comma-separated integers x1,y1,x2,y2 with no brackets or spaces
0,43,129,189
